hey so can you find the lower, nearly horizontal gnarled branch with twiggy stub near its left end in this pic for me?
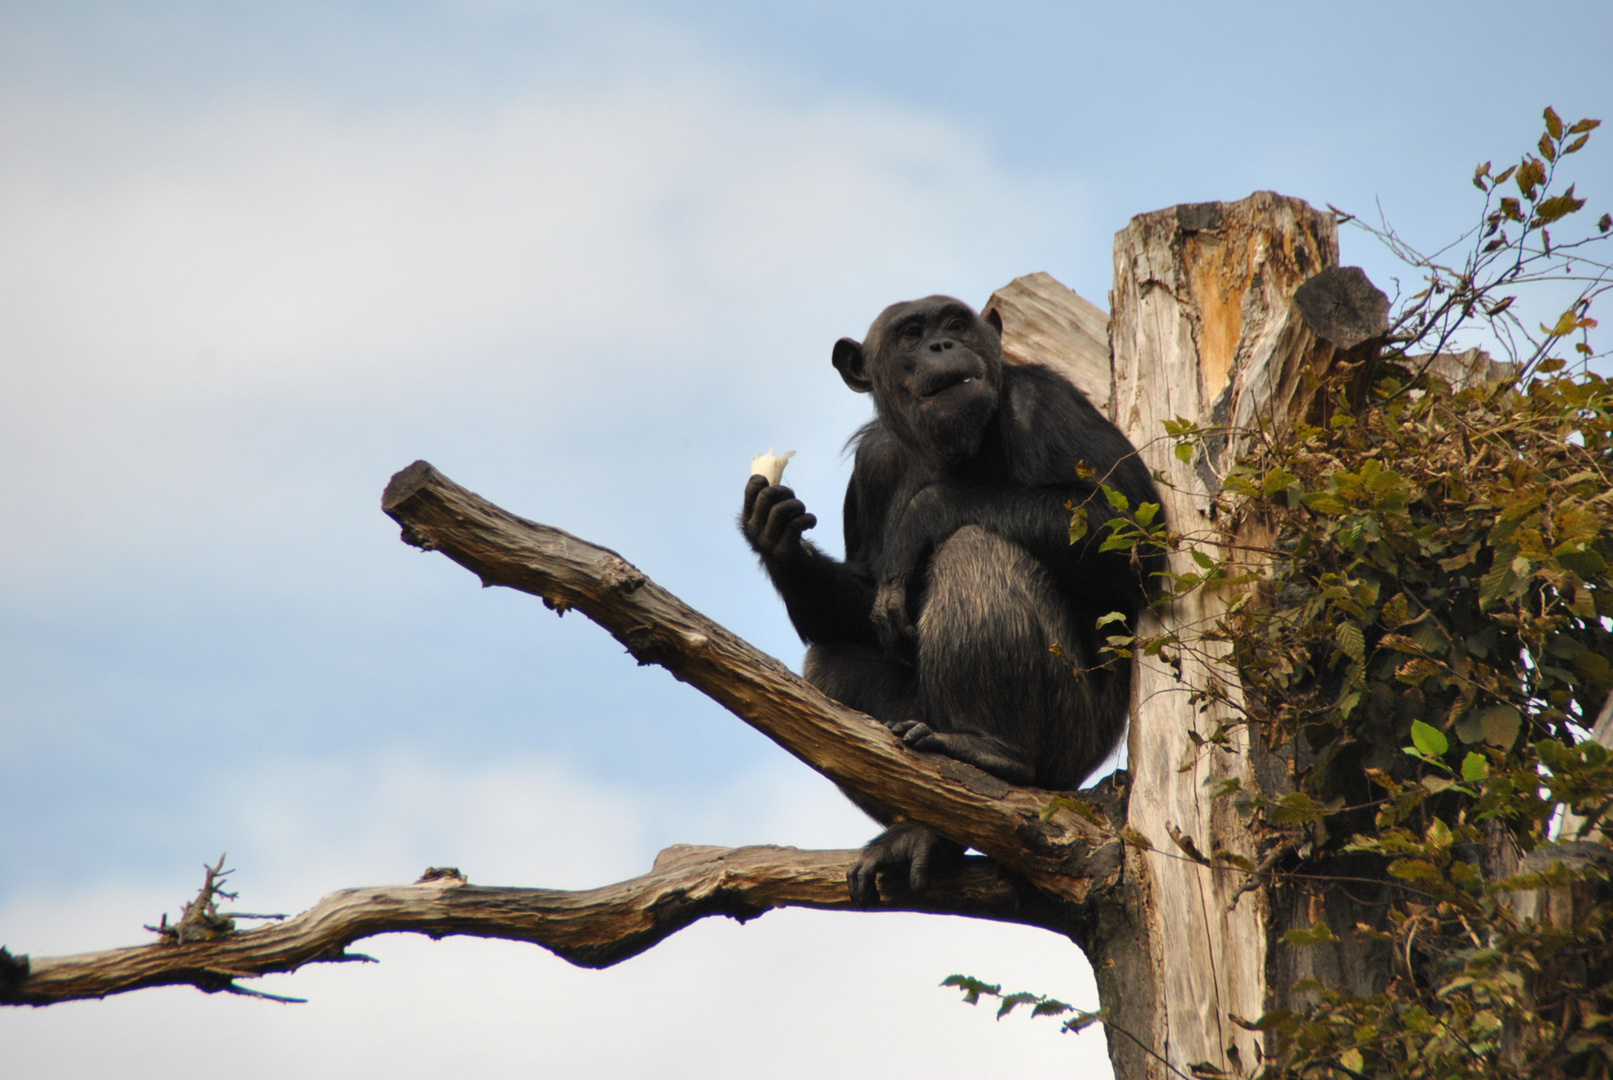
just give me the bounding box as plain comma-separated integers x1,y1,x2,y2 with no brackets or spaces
9,845,1058,1006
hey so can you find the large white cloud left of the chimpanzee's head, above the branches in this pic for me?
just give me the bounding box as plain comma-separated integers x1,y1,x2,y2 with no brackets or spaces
0,52,1077,599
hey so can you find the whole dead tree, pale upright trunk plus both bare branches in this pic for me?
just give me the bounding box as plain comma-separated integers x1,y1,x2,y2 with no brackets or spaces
0,192,1382,1080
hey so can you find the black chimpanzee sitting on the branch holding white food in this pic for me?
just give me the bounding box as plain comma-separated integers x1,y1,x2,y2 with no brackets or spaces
740,297,1160,904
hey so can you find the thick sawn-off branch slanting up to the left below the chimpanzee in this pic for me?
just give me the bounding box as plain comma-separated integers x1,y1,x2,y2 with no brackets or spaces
382,461,1121,903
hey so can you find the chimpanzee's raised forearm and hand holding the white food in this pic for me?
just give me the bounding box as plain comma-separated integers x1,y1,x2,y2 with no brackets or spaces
739,476,876,645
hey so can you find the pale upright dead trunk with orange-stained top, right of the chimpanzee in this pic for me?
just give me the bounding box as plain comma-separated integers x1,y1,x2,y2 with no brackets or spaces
1105,192,1386,1077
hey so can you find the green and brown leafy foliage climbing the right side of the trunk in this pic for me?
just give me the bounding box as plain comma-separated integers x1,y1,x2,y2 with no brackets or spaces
1206,110,1613,1078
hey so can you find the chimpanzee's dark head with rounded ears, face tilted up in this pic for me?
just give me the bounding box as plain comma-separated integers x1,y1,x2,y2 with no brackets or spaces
834,297,1003,463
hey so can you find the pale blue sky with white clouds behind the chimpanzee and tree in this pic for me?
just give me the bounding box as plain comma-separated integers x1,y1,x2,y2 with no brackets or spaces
0,0,1613,1077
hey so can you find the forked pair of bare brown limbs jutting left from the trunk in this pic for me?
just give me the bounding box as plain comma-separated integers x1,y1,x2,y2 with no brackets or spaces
0,461,1126,1004
